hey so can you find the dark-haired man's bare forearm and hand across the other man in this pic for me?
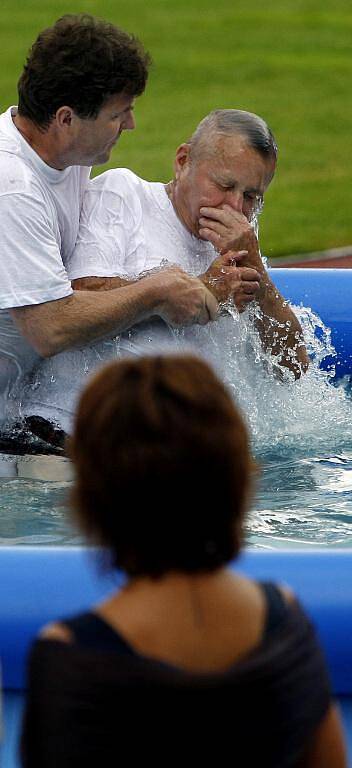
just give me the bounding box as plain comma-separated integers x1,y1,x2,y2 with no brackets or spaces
10,267,218,357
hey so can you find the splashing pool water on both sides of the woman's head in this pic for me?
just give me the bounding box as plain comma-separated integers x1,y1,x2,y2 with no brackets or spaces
0,307,352,548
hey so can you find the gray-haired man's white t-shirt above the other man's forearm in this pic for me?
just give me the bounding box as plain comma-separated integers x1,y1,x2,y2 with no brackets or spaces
67,168,216,280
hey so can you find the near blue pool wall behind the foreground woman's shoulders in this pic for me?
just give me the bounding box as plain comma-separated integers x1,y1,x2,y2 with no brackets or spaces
0,547,352,695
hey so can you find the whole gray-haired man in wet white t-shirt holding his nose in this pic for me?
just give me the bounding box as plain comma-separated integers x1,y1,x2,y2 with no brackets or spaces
22,110,308,440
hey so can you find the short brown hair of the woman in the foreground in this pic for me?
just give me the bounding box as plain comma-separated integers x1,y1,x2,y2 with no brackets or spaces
70,355,251,576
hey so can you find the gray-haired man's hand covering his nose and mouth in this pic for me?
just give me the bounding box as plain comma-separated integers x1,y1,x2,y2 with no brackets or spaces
199,205,263,272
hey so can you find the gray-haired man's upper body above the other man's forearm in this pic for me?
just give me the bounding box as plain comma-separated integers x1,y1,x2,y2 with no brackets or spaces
68,109,308,378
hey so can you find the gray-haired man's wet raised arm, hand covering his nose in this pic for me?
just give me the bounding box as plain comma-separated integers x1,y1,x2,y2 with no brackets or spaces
200,205,309,378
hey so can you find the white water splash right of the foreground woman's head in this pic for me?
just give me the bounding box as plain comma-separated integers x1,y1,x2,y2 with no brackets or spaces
167,303,352,459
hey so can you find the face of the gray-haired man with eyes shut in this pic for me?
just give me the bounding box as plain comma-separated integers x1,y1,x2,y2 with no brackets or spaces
174,136,275,236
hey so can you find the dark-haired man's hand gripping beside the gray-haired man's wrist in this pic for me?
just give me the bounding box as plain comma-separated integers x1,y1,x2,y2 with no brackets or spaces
151,267,218,326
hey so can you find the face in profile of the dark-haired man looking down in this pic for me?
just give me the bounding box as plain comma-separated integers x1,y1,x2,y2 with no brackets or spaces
71,94,135,165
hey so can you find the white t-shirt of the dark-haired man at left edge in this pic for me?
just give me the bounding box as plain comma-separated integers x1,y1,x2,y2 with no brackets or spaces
0,107,89,421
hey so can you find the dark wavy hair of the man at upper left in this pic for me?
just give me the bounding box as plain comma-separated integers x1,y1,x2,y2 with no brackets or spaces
18,14,150,129
